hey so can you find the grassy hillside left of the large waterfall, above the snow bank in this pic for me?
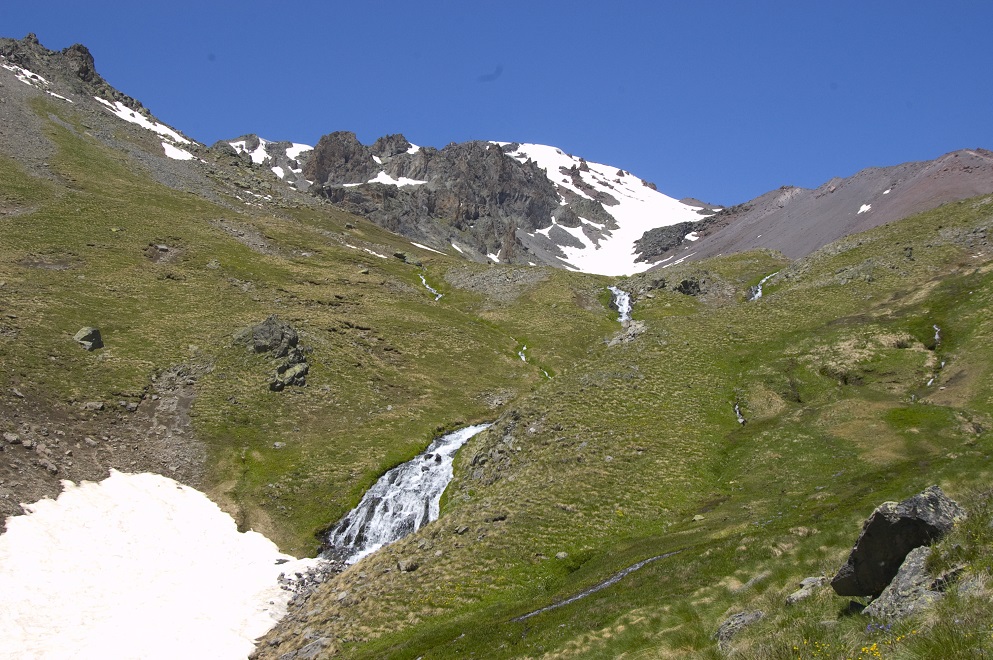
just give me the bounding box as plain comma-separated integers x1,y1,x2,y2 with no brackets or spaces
0,101,615,554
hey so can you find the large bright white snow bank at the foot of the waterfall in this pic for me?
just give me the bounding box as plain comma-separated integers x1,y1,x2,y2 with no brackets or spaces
0,471,318,658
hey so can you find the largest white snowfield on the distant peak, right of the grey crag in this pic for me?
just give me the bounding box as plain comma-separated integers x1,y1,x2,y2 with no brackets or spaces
494,142,700,275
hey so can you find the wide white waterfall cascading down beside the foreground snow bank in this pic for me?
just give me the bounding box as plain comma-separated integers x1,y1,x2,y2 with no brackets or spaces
326,424,490,564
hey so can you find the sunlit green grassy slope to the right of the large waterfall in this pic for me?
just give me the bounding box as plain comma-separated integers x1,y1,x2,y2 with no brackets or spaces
262,193,993,658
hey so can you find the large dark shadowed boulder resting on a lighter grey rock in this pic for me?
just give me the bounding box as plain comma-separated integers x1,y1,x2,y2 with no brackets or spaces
831,486,964,597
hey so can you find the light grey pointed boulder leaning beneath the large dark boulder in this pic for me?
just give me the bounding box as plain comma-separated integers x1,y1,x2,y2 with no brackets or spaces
862,546,961,619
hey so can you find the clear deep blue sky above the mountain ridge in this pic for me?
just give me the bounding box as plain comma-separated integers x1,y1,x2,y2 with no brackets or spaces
0,0,993,204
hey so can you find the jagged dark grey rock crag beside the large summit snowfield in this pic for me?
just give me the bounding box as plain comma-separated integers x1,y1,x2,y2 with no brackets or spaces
304,131,568,263
